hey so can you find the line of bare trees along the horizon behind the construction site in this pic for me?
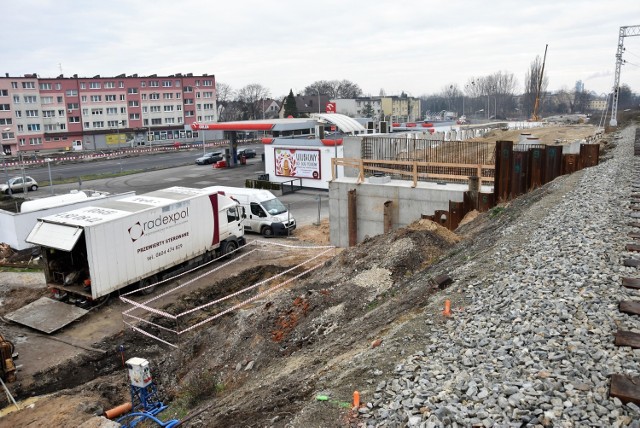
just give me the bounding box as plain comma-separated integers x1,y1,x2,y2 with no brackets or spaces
216,56,640,122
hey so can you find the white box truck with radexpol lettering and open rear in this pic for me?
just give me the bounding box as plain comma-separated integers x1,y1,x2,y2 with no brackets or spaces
26,187,246,307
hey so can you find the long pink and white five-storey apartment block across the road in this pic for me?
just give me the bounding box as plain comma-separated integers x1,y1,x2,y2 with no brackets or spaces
0,73,217,155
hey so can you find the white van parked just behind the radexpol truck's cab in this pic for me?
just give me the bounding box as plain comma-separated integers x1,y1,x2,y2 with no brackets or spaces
212,186,296,237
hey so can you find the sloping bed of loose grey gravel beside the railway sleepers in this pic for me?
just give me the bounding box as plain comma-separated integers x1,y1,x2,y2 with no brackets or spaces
360,127,640,427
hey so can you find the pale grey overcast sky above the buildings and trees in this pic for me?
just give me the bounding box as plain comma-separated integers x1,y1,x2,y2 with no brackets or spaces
0,0,640,97
